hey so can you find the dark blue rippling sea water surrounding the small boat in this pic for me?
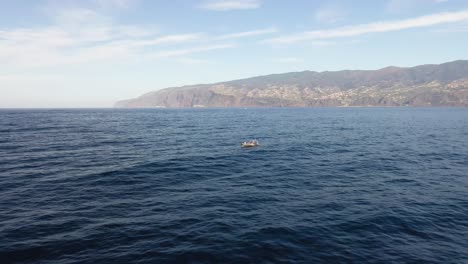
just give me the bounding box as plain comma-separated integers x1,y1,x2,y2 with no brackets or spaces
0,108,468,264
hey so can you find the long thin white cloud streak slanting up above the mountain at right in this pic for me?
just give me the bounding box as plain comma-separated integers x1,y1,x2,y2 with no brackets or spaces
264,10,468,43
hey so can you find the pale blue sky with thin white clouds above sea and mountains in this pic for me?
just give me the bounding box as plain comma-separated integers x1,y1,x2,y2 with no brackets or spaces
0,0,468,108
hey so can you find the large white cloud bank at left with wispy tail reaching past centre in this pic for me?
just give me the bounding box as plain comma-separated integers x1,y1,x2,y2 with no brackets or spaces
0,2,277,68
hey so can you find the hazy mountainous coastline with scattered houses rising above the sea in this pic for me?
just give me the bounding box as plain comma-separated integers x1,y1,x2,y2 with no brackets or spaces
116,61,468,108
